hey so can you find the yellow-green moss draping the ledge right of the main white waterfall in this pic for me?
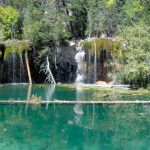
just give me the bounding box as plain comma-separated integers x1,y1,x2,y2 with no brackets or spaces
81,38,121,57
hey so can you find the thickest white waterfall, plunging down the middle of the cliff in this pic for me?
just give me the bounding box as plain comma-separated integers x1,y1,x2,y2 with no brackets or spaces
75,46,85,83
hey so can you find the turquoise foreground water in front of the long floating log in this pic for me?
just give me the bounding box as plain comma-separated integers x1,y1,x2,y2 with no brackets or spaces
0,104,150,150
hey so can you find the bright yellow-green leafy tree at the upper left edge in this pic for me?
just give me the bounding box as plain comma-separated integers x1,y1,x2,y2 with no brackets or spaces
0,6,19,40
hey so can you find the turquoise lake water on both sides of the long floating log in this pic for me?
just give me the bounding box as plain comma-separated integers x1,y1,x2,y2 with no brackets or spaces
0,85,150,150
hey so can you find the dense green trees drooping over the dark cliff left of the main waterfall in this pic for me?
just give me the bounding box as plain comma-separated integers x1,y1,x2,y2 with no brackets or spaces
23,0,71,53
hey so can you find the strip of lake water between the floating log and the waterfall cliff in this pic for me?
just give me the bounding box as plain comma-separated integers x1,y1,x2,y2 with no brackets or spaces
0,85,150,101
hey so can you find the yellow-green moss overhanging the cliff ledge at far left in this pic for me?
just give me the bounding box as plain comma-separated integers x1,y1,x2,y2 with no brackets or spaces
4,40,29,60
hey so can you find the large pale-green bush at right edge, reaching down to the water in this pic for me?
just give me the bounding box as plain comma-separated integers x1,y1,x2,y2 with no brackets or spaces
118,21,150,86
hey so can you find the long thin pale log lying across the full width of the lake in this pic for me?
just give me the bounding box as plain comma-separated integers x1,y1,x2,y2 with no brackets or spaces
0,100,150,105
